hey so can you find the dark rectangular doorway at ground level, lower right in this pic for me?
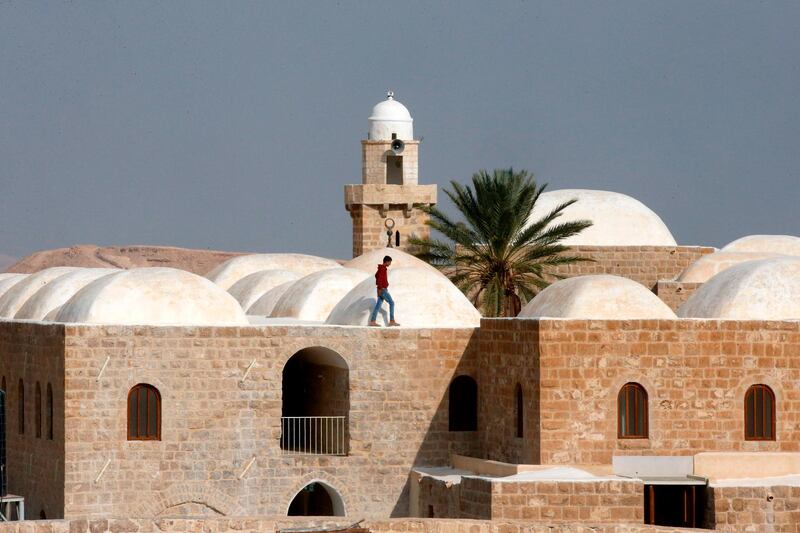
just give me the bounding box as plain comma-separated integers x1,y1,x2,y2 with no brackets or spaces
644,485,706,527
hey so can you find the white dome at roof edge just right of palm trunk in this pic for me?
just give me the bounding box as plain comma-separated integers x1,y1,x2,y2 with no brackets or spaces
519,274,676,320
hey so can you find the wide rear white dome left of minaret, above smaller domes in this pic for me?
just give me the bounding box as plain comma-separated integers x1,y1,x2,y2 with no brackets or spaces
206,254,341,290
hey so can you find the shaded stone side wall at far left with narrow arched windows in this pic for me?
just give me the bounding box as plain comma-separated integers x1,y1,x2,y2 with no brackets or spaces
0,321,64,518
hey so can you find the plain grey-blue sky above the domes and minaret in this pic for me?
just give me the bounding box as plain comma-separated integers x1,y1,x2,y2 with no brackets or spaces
0,0,800,258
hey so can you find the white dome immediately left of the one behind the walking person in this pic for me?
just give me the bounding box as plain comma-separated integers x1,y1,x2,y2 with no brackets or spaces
270,268,374,322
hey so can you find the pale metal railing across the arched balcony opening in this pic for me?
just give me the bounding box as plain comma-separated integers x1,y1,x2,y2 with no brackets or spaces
281,416,347,455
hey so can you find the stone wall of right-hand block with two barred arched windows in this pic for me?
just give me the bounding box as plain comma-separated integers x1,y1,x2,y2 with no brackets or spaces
479,319,800,465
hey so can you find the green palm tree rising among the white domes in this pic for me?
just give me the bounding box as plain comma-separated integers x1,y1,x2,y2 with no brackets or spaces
410,168,592,316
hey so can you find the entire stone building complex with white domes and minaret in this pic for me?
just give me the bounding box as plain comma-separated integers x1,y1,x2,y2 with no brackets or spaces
0,99,800,533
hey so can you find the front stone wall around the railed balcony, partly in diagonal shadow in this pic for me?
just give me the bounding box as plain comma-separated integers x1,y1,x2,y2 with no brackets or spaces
51,325,479,518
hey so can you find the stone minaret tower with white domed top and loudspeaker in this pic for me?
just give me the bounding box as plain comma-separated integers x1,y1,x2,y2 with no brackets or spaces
344,91,436,257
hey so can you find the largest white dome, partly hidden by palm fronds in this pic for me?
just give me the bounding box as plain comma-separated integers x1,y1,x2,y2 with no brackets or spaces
528,189,676,246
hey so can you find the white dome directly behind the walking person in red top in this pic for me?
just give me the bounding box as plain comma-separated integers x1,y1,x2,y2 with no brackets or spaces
326,267,481,328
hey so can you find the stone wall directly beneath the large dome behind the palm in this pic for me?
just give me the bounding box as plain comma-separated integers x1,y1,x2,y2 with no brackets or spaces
555,246,714,290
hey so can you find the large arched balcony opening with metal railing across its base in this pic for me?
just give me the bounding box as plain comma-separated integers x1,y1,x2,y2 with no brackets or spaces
281,346,350,455
